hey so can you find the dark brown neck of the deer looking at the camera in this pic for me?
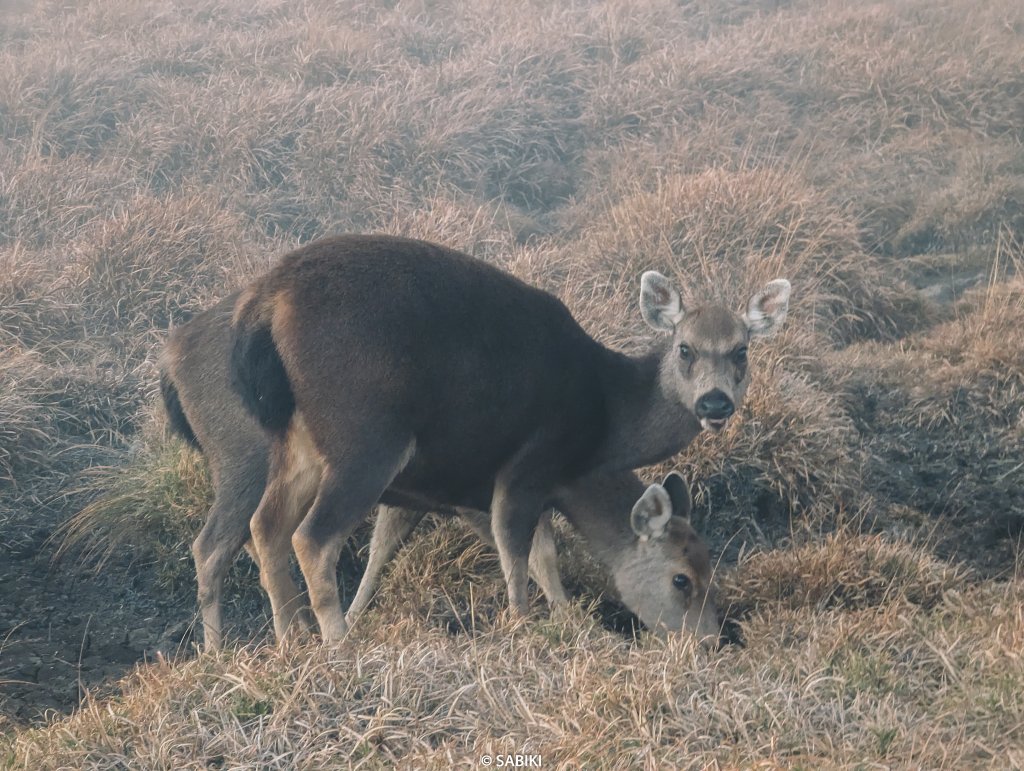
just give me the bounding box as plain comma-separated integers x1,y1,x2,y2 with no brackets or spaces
593,345,700,471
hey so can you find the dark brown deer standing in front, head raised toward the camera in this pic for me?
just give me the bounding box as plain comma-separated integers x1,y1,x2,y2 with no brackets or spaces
230,235,790,640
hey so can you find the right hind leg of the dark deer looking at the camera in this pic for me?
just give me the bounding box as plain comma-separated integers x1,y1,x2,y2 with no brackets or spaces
292,430,416,641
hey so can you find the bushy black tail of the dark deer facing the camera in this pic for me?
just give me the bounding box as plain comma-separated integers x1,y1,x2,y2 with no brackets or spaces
231,313,295,432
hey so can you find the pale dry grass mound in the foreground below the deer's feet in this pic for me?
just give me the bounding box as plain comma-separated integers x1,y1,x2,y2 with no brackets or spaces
6,543,1024,768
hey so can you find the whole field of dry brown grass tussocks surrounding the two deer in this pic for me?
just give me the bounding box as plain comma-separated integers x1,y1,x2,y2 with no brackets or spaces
0,0,1024,770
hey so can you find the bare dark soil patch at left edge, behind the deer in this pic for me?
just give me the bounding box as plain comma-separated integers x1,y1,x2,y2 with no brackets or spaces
0,505,193,726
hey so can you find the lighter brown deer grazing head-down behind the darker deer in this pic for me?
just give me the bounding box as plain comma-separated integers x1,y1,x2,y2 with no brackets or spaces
160,293,719,650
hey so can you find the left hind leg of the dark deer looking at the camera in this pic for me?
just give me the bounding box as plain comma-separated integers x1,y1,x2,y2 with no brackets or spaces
249,438,323,642
